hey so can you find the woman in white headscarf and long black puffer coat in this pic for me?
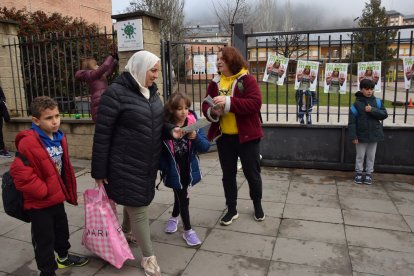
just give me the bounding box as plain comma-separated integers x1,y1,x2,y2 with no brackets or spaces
91,51,181,275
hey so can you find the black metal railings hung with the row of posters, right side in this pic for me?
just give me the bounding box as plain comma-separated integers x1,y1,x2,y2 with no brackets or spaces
241,25,414,124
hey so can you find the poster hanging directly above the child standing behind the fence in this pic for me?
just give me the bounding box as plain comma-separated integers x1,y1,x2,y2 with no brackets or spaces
295,60,319,91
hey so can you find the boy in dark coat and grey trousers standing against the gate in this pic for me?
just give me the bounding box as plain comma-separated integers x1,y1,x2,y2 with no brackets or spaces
348,79,388,185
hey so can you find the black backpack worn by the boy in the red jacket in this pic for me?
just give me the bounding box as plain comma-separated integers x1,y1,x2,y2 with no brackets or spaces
1,152,30,222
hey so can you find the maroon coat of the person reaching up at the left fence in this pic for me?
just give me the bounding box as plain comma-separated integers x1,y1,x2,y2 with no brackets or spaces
75,56,118,122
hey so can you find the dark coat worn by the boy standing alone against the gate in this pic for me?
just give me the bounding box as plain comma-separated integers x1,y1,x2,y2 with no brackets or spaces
348,91,388,143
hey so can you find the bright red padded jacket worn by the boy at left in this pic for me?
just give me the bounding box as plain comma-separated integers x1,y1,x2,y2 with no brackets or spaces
10,129,77,210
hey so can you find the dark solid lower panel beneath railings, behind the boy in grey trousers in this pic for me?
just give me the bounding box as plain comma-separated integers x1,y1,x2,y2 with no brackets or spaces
261,125,414,174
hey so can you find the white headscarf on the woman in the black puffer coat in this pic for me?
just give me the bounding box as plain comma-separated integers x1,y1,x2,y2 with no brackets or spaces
125,51,160,98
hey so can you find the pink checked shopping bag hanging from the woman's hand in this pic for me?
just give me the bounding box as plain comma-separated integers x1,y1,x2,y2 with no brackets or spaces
82,186,134,269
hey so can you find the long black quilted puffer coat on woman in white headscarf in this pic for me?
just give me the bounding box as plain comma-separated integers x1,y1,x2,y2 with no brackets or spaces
92,72,164,207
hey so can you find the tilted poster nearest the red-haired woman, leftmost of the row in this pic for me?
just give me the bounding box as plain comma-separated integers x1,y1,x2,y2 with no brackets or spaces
263,53,289,85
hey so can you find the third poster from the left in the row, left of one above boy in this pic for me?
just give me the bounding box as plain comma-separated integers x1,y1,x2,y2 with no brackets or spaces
323,63,348,94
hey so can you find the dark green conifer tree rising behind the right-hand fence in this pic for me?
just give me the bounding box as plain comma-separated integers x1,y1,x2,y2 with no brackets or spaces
352,0,397,73
